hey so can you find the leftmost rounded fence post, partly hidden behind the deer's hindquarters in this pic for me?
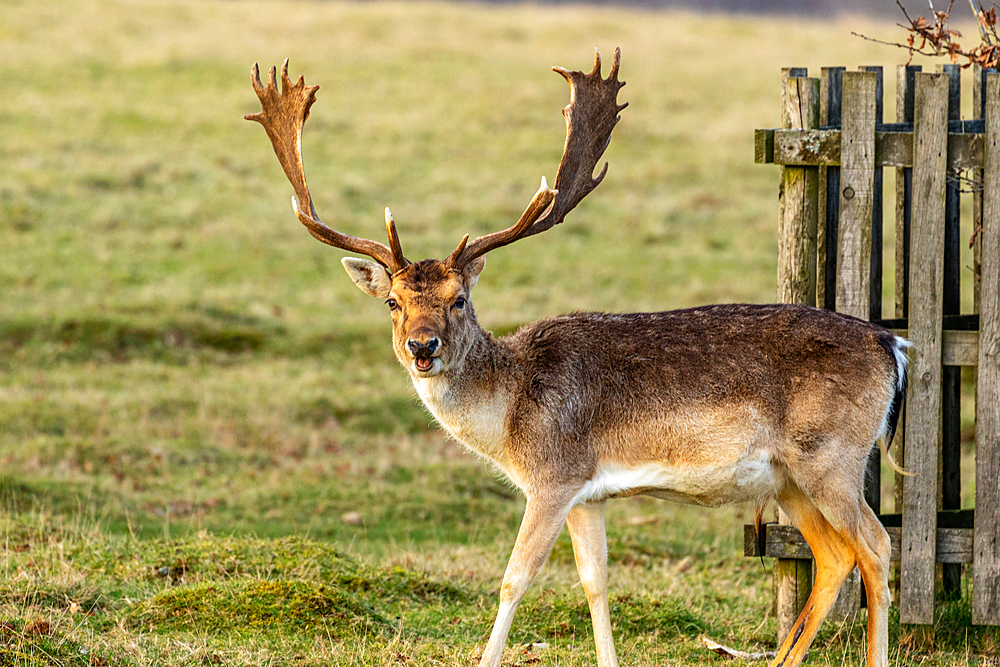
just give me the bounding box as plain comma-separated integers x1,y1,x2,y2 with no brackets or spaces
774,68,820,645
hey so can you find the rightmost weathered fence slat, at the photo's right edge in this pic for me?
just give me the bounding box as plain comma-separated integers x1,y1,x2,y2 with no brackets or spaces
972,73,1000,625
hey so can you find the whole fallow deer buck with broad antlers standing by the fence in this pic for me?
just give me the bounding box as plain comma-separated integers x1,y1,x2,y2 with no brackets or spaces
246,51,909,667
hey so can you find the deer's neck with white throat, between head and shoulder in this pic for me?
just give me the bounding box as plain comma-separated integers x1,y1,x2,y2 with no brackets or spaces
411,326,515,464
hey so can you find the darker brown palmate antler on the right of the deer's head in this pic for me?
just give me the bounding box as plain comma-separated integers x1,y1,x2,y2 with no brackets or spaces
447,49,628,269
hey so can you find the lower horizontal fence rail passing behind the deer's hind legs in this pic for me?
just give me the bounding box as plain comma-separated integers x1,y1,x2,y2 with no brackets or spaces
743,523,973,564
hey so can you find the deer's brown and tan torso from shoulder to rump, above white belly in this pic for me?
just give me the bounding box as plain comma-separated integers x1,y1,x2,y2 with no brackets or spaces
503,305,903,504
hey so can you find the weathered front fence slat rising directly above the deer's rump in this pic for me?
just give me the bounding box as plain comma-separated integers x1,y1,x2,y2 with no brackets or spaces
837,72,877,319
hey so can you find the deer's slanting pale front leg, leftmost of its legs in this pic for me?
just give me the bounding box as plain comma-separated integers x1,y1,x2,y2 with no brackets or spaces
479,493,573,667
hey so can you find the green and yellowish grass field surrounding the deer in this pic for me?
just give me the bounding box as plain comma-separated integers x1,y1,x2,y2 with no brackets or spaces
0,0,1000,666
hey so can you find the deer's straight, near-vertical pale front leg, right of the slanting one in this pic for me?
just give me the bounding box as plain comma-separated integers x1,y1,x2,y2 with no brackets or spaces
566,502,618,667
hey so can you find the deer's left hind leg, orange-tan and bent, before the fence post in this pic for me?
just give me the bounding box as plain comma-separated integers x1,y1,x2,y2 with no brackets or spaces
771,484,855,667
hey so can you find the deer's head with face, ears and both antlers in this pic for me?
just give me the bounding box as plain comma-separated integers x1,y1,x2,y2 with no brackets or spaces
245,49,627,377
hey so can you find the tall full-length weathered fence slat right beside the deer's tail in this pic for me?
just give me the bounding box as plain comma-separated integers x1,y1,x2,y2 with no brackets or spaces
899,74,948,624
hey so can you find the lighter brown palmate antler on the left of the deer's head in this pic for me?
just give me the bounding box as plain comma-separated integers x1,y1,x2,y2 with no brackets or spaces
244,58,410,273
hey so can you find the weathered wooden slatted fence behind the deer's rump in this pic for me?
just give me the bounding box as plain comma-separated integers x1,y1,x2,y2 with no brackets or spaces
745,65,1000,641
